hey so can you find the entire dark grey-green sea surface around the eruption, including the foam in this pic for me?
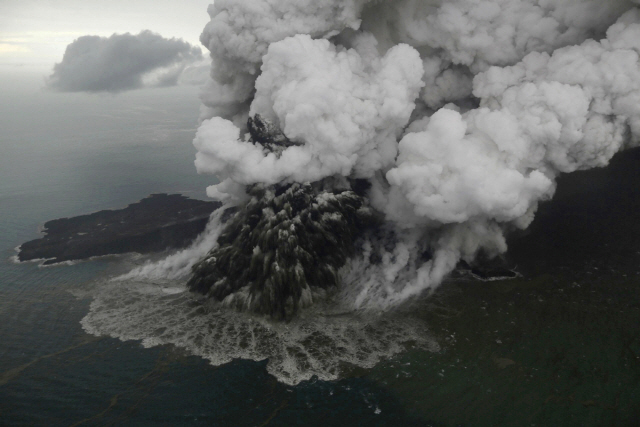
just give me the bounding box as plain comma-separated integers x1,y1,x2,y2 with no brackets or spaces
0,79,640,426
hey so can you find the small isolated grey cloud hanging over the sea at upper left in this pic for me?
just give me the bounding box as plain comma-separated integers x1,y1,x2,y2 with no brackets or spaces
47,30,203,92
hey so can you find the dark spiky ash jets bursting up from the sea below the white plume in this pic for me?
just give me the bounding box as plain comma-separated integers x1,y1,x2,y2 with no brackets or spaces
188,183,371,319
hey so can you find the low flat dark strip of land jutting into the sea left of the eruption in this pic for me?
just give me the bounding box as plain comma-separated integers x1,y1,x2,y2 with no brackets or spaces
18,194,220,264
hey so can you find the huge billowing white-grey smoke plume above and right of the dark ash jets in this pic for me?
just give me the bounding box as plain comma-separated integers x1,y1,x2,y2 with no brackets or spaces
182,0,640,318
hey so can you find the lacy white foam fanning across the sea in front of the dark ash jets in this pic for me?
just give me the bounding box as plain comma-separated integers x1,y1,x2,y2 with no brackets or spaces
81,279,439,385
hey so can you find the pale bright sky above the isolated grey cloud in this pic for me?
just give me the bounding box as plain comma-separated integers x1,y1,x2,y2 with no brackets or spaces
0,0,212,84
